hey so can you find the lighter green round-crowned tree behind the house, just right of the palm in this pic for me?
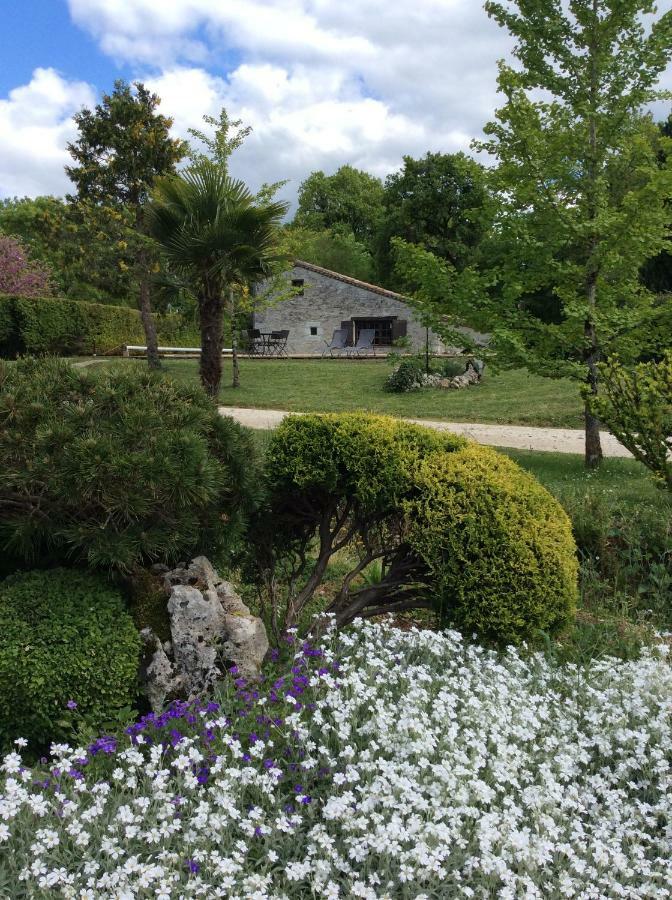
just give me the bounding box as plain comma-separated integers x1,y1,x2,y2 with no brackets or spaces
294,166,384,250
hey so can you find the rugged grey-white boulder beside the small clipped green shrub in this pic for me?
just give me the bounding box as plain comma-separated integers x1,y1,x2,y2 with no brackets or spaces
142,556,268,710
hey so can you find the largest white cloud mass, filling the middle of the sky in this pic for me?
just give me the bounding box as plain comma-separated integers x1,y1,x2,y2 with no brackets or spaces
69,0,509,205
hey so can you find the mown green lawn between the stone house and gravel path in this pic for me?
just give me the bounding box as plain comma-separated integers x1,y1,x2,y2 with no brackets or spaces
107,359,582,428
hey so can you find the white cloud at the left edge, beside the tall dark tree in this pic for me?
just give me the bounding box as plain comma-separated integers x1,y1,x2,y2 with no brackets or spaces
0,69,95,196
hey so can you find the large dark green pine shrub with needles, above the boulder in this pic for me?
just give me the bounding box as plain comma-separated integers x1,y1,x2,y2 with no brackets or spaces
0,359,257,572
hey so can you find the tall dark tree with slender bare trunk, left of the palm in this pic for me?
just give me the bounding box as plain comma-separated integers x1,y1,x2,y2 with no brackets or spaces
66,80,187,368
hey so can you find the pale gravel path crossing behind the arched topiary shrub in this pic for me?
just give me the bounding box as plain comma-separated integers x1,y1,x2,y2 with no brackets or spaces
219,406,631,457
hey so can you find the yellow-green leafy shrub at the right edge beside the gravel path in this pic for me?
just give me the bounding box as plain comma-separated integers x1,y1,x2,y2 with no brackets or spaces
591,351,672,491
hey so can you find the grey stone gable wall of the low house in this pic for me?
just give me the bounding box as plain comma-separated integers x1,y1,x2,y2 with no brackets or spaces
254,263,444,355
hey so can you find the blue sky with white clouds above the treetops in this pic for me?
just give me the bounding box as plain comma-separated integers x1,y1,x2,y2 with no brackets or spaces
0,0,672,211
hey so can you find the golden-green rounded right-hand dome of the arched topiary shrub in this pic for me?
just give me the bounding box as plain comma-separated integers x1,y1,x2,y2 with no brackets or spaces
407,444,578,643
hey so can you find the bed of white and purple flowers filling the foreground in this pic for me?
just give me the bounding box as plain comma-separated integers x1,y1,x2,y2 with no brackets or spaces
0,623,672,900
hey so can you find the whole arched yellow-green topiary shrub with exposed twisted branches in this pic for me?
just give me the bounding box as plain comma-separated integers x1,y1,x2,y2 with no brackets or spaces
253,414,577,643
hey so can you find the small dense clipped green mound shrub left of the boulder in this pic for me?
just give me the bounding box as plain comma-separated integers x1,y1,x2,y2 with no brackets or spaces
0,569,140,749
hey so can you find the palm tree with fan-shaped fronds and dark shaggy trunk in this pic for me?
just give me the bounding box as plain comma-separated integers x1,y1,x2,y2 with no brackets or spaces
147,159,287,397
